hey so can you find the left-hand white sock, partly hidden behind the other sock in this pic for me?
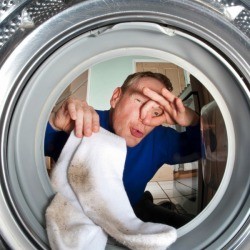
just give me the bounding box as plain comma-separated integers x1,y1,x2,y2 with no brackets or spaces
45,130,107,250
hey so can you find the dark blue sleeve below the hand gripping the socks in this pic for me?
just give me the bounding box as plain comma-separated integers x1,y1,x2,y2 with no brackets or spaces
44,122,69,161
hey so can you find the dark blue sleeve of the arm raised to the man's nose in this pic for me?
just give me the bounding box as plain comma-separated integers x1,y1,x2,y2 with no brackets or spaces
158,124,201,165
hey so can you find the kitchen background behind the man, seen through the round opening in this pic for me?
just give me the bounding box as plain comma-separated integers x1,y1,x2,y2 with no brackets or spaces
46,56,227,220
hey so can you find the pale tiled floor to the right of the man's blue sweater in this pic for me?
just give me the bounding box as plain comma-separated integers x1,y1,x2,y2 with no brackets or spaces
146,177,198,215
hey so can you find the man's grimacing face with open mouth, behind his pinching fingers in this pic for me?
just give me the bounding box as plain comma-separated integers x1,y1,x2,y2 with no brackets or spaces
110,77,164,147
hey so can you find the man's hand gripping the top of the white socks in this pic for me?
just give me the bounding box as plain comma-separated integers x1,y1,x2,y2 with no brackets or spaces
49,99,100,137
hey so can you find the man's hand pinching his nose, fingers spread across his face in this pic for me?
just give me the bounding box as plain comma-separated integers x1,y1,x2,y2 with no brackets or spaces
141,88,199,127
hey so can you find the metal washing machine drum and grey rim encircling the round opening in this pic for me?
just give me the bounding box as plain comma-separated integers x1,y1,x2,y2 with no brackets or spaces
0,0,250,249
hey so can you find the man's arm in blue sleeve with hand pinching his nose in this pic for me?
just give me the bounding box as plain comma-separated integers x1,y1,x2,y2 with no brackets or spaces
141,88,201,164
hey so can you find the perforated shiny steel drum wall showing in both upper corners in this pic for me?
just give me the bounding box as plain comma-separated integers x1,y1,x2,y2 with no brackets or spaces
0,0,250,52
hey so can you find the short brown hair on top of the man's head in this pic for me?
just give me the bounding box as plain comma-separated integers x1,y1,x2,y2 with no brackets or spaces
121,71,173,93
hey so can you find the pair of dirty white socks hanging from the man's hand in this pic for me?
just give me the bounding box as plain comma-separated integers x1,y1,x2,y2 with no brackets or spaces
46,128,177,250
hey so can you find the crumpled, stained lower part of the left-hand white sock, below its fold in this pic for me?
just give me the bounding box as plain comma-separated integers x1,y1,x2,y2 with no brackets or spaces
45,193,107,250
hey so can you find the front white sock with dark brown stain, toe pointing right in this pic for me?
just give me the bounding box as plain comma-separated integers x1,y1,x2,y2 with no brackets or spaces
68,129,177,250
